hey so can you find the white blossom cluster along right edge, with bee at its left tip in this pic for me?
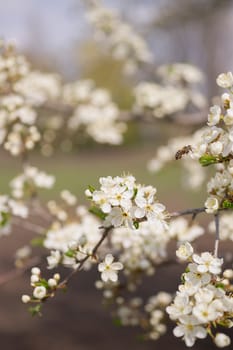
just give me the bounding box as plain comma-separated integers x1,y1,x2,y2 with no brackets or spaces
169,72,233,214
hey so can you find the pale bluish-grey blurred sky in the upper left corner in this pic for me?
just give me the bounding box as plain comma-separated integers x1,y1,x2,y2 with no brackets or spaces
0,0,84,66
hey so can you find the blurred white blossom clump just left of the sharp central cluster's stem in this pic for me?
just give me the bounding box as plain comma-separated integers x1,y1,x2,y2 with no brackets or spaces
43,205,101,269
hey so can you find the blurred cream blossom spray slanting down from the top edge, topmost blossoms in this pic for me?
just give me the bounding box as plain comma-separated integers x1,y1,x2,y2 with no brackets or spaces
84,2,152,74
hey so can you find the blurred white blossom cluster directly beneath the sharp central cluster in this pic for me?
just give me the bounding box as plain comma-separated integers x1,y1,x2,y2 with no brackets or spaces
111,221,170,284
